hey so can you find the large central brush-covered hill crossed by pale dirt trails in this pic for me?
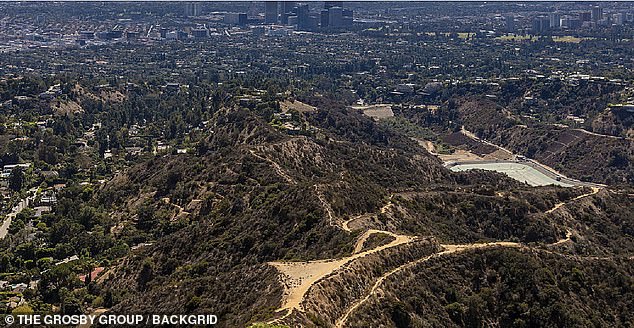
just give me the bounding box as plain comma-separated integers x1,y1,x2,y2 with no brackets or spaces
92,104,634,326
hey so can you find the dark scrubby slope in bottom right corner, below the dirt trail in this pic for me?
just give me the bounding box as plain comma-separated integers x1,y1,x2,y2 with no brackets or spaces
348,247,634,327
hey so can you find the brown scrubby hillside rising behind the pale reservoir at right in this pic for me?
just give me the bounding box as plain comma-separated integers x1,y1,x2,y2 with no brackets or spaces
459,99,634,185
